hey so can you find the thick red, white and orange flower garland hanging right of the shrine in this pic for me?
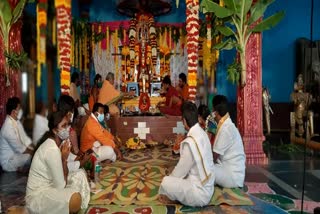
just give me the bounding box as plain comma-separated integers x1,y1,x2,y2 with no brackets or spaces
186,0,200,101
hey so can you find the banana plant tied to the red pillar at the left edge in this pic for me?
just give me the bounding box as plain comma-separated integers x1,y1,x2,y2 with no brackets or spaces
0,0,27,86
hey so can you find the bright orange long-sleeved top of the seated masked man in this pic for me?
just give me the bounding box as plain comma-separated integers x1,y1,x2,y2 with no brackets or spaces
80,115,115,152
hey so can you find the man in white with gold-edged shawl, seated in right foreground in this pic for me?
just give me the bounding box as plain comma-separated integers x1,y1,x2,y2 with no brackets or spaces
159,102,215,206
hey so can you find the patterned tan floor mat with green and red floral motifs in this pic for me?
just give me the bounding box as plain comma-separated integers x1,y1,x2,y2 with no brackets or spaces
90,147,253,205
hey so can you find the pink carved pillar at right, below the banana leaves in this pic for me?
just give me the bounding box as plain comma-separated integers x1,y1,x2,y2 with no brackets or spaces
237,30,268,164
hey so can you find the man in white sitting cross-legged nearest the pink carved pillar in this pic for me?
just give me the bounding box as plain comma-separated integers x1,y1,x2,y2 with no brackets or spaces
212,95,246,188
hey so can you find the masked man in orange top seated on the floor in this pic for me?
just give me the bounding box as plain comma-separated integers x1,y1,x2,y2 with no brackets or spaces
80,103,122,162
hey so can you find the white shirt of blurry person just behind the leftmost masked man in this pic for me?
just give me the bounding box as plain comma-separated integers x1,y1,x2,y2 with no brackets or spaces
32,114,49,145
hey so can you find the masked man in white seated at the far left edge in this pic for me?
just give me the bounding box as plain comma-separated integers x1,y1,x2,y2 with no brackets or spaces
0,97,34,171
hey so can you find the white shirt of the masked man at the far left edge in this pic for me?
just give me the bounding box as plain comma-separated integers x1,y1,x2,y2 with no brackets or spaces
0,115,32,164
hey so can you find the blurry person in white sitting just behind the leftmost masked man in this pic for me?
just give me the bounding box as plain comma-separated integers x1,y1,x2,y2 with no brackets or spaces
32,102,49,146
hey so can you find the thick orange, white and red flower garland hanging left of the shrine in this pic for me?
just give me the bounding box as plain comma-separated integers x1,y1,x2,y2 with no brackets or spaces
55,0,72,94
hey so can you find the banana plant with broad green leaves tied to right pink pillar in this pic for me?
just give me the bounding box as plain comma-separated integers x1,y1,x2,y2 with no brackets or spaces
200,0,284,87
